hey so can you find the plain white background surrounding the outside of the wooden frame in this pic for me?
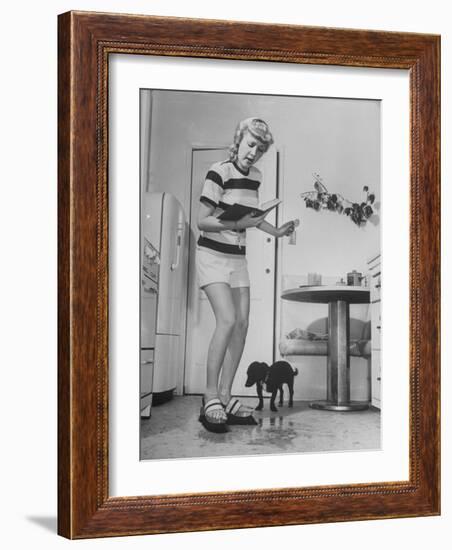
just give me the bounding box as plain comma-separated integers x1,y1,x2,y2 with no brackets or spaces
0,0,452,550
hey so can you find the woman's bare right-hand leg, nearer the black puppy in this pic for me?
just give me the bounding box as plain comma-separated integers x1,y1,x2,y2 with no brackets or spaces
218,287,253,416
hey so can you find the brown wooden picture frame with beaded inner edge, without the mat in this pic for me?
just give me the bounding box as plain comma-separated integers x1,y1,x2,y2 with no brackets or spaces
58,12,440,538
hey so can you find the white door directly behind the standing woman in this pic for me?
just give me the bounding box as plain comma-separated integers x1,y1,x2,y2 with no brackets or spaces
185,148,277,395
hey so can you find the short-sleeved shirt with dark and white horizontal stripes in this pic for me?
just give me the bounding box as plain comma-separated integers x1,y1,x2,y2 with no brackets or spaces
198,160,262,257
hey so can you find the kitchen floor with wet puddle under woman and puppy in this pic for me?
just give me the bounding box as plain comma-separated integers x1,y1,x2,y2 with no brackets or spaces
141,396,380,460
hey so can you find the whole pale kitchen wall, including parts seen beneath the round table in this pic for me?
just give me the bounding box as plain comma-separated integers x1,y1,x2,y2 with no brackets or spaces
143,90,380,400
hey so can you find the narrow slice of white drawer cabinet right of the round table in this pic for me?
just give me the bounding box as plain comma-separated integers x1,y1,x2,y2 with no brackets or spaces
367,254,381,409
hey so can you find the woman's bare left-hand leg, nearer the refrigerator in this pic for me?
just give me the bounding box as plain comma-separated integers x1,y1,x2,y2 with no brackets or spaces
204,283,236,418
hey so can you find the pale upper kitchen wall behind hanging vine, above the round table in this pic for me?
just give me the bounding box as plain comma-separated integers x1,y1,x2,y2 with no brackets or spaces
148,91,380,276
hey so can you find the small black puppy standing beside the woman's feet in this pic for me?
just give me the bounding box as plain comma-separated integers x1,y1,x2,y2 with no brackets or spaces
245,361,298,412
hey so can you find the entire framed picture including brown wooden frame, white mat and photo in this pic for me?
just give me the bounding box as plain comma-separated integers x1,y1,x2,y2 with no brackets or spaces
58,12,440,538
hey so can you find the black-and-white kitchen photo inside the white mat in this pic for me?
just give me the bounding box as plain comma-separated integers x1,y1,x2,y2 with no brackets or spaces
139,89,383,460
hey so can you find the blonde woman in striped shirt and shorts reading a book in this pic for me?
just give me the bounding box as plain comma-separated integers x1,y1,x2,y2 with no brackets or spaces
197,118,296,433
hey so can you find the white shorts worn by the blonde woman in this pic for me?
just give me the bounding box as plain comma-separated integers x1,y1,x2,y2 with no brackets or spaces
196,247,250,288
